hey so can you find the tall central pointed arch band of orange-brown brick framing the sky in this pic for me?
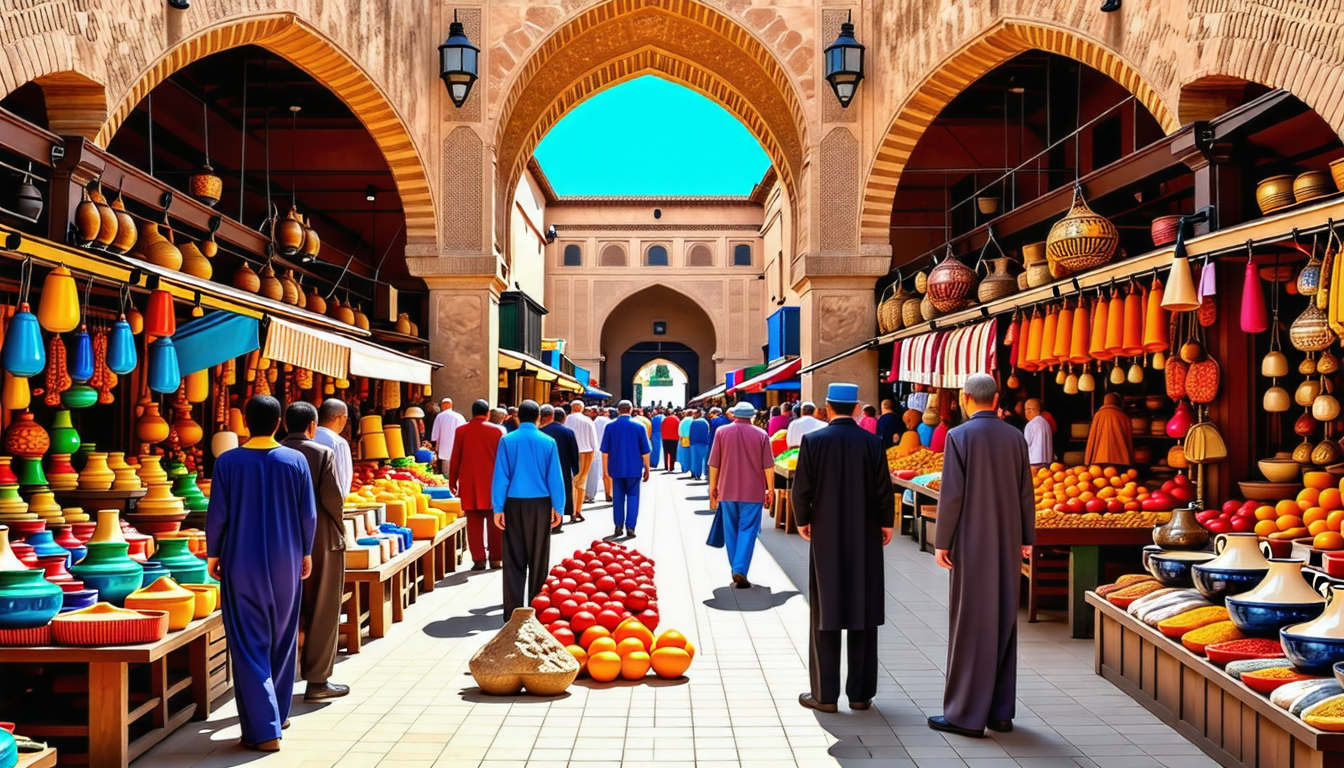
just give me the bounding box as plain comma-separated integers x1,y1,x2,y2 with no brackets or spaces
495,0,808,252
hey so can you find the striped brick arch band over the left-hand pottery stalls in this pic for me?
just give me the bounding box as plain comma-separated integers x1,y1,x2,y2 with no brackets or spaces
94,13,438,247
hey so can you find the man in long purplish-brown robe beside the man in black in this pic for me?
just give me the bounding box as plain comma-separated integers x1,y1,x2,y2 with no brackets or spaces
929,374,1036,736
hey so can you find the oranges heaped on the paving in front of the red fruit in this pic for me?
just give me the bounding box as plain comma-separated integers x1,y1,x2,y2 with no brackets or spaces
569,619,695,683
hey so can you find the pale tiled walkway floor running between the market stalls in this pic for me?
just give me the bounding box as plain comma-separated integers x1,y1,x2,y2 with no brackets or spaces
136,472,1215,768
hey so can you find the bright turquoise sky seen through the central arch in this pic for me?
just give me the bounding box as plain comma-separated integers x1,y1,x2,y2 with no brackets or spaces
536,75,770,195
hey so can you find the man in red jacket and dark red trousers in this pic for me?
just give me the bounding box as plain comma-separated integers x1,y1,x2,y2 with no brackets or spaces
448,399,504,570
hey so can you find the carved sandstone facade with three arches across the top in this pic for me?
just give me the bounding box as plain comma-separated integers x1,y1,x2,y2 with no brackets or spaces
0,0,1344,398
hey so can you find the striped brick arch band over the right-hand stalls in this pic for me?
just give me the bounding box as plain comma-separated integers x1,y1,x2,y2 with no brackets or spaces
859,22,1180,243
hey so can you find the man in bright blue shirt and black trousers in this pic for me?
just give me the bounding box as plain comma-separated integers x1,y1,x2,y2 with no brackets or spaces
491,399,564,620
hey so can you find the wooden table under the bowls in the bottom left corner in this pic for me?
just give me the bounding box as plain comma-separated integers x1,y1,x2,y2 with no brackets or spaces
0,611,233,768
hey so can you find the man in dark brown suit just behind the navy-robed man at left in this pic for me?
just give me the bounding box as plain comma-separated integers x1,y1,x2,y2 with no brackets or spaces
281,401,349,702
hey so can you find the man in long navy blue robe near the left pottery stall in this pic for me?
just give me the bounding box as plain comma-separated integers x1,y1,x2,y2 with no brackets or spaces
206,395,317,752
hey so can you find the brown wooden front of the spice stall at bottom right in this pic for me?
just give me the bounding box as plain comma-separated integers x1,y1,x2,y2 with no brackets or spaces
1087,592,1344,768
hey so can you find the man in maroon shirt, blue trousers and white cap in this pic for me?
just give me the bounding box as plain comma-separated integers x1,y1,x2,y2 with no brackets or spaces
710,401,774,589
